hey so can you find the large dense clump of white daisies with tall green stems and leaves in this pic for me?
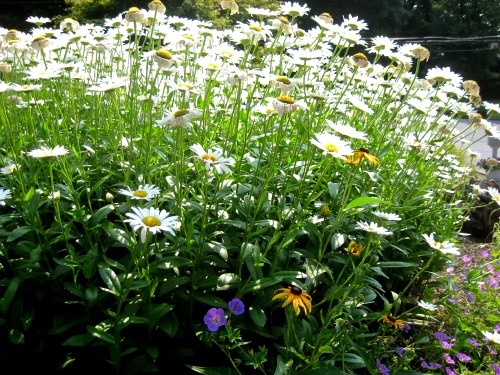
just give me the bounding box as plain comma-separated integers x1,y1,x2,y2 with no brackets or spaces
0,0,498,374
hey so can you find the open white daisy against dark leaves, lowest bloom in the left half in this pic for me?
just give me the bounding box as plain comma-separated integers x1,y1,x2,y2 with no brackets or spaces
124,207,179,243
